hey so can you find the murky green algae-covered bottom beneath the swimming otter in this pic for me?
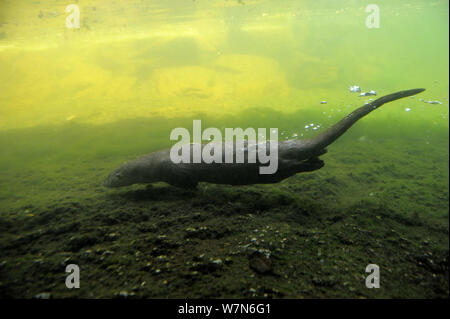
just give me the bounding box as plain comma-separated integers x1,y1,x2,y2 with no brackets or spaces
0,118,449,298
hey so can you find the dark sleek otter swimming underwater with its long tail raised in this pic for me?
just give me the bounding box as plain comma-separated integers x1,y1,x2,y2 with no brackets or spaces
104,89,425,187
